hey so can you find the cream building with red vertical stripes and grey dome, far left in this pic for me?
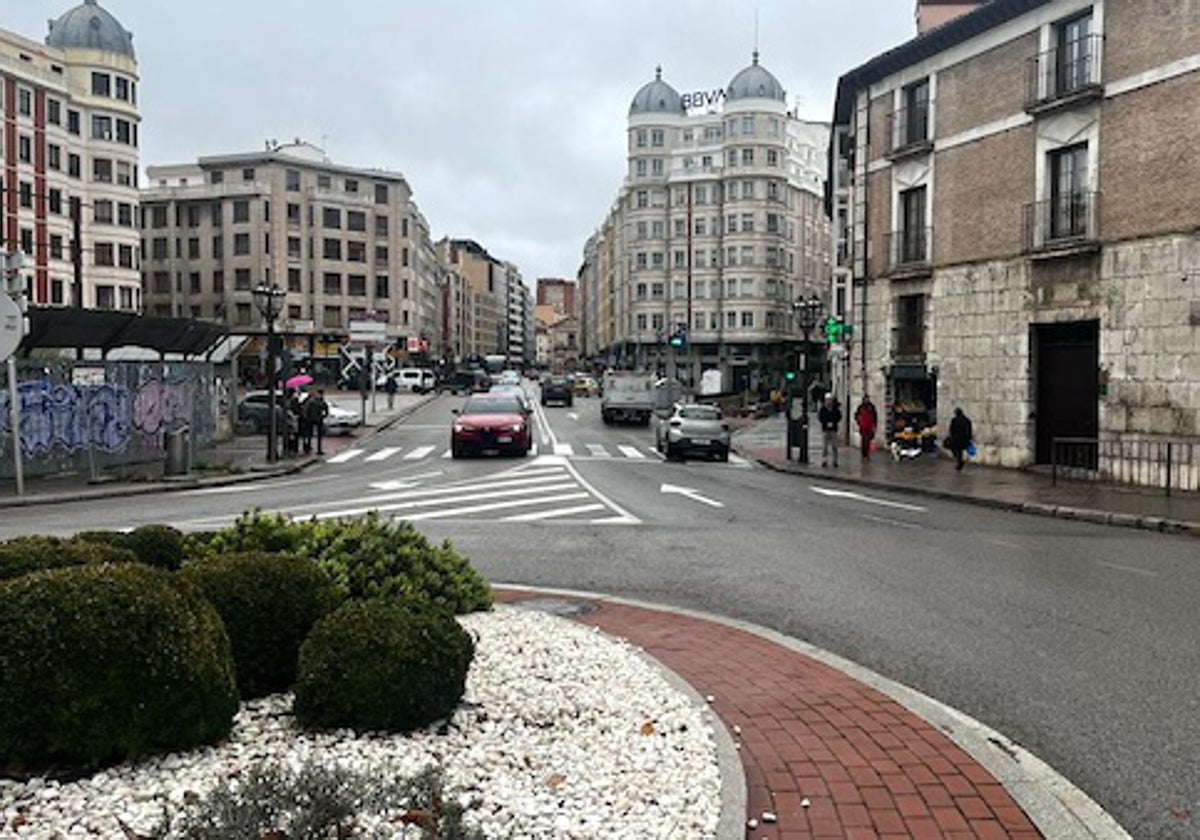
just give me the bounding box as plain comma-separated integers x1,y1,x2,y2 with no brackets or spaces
0,0,141,312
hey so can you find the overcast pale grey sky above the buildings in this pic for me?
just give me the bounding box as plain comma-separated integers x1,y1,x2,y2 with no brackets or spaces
7,0,916,287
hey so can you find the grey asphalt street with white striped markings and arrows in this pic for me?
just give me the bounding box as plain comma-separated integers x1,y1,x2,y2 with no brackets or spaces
0,386,1200,836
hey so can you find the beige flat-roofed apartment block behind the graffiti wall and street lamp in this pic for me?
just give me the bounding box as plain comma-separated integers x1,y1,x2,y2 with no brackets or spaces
142,139,420,338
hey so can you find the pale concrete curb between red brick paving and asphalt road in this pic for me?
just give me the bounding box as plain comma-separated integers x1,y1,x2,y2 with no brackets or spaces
492,583,1133,840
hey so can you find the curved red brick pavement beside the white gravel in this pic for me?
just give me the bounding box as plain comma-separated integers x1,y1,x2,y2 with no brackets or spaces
497,589,1042,840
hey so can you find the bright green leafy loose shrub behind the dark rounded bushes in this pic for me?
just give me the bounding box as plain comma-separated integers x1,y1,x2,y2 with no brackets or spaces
187,510,492,613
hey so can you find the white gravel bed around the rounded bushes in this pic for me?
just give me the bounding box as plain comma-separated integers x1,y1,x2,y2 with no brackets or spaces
0,606,721,840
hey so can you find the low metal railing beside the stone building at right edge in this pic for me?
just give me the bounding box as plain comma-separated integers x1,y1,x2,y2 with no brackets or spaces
1050,436,1200,496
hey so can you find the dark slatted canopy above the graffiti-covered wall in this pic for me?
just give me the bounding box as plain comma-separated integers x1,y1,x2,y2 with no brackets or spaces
17,307,229,356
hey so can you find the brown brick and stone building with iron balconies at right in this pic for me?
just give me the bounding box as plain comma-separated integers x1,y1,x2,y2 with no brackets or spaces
829,0,1200,467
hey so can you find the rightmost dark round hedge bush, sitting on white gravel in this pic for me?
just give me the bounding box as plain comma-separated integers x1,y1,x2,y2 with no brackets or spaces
294,598,475,732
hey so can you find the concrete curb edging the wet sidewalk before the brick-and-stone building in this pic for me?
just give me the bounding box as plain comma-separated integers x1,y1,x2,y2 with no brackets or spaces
733,444,1200,536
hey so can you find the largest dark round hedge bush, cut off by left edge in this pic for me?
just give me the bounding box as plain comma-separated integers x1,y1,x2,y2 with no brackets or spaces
0,563,238,772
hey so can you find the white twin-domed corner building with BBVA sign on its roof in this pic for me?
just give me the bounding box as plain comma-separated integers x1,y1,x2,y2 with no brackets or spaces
577,53,833,391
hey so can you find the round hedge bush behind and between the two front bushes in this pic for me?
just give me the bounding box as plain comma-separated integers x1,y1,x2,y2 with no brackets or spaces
179,552,338,698
